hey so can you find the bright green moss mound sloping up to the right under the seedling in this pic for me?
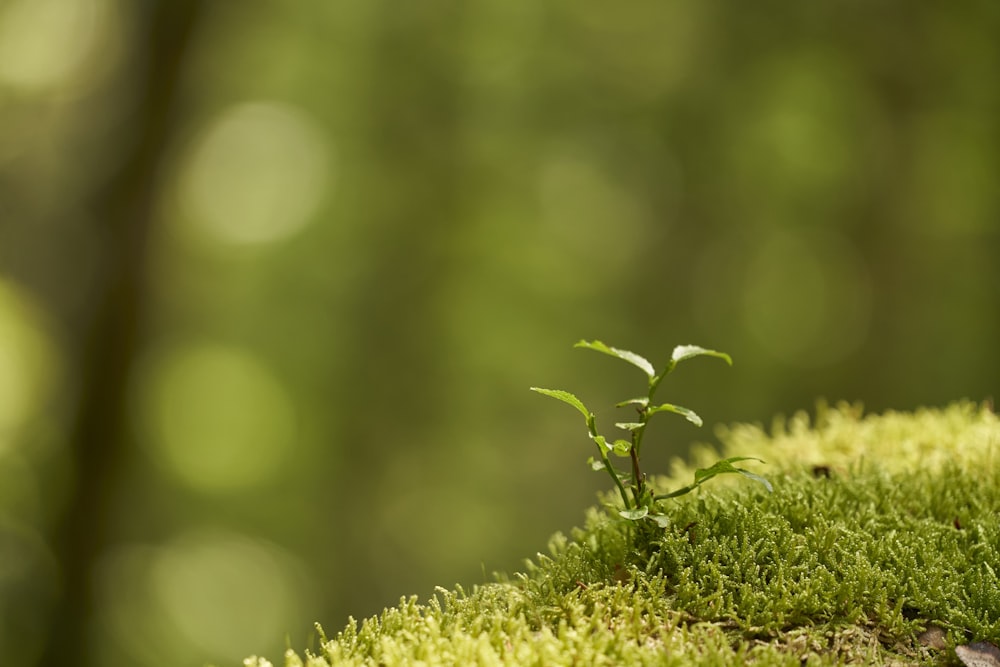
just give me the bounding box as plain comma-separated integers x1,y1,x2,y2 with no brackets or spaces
245,403,1000,667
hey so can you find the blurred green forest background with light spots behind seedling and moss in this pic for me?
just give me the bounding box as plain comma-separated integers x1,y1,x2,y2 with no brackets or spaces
0,0,1000,667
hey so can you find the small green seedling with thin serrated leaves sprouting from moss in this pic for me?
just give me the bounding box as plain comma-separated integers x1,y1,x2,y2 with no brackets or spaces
531,340,772,527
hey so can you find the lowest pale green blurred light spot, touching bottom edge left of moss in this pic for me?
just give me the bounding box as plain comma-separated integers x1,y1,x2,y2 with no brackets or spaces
96,526,314,666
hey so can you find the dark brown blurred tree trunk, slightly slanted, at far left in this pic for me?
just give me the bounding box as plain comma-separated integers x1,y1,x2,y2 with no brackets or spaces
42,0,202,667
